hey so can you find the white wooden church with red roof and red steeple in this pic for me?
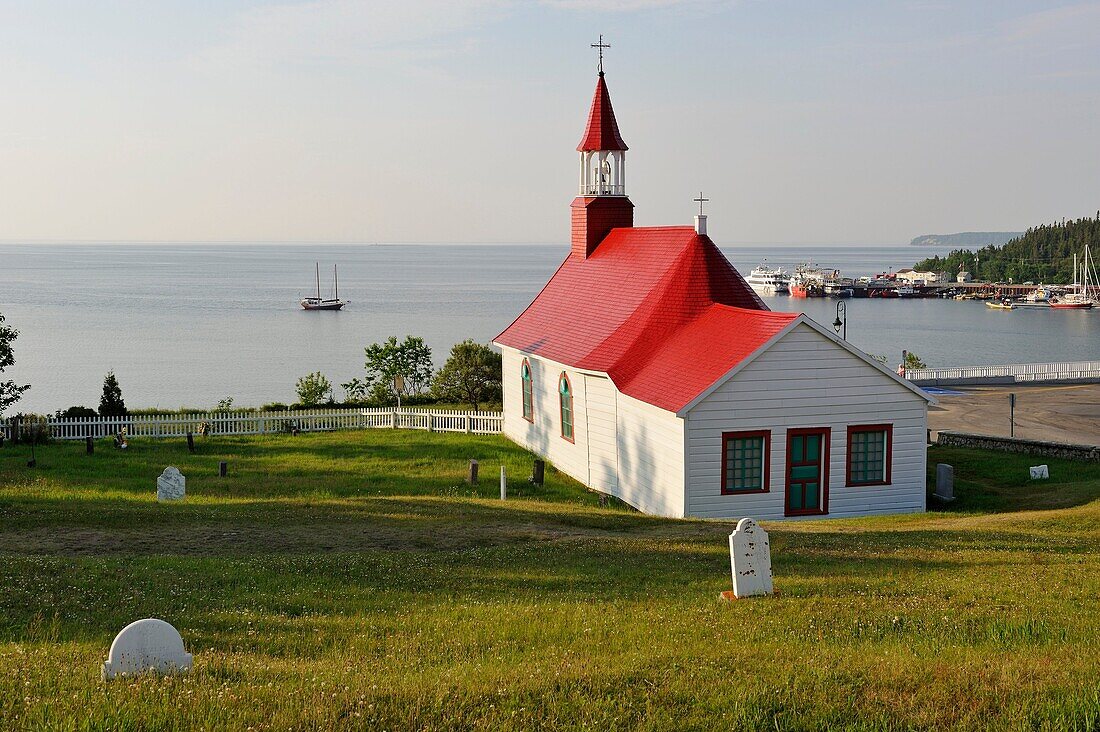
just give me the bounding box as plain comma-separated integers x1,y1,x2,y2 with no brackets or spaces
495,62,933,520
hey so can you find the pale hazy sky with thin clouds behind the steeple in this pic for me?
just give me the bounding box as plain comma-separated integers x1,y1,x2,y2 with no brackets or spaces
0,0,1100,244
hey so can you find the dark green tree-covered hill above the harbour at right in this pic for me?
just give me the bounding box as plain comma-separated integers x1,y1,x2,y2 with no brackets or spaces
913,211,1100,284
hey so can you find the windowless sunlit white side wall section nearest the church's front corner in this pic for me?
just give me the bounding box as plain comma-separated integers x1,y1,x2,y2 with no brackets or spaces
612,391,684,517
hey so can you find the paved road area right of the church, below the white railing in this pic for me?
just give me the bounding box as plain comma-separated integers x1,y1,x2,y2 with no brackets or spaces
928,384,1100,445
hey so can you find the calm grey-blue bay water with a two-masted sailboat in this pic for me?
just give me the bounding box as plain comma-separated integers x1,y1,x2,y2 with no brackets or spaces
0,244,1100,412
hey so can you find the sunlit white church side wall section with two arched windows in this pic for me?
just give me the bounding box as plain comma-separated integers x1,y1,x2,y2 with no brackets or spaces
501,347,589,484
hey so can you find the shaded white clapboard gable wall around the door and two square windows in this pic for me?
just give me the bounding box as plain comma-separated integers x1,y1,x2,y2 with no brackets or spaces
685,325,927,520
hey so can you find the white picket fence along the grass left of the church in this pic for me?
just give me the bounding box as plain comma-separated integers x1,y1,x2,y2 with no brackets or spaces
2,407,504,439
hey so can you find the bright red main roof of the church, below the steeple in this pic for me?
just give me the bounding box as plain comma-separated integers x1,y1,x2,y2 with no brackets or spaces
496,227,798,412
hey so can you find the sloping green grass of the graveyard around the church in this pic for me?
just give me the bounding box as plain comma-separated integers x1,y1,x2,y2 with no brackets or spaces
0,430,1100,730
